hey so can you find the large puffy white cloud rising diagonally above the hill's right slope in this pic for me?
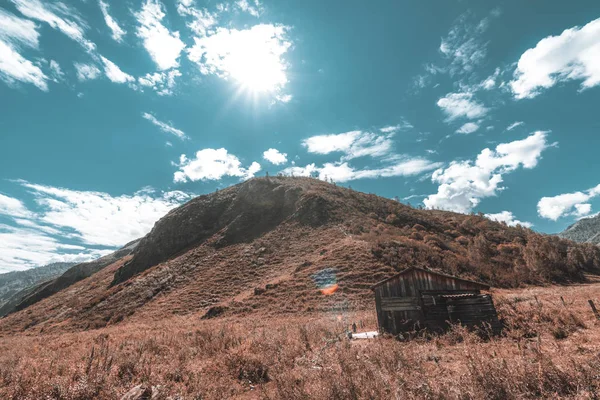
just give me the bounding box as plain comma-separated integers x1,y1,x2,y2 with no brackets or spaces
424,131,549,213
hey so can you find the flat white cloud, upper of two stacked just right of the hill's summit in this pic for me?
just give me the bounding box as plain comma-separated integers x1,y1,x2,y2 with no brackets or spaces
302,128,394,160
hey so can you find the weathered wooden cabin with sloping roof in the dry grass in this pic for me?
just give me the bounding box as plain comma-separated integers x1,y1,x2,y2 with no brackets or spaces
371,267,501,335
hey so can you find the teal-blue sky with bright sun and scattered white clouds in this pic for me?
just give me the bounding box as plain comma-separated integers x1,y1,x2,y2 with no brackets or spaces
0,0,600,273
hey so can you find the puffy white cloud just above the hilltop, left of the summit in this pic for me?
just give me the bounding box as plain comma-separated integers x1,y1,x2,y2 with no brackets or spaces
173,148,261,182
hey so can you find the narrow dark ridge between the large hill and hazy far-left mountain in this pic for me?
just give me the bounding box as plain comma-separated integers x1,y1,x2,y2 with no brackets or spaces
0,239,139,317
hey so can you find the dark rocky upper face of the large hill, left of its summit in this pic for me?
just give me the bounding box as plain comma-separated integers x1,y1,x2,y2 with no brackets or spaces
113,177,329,285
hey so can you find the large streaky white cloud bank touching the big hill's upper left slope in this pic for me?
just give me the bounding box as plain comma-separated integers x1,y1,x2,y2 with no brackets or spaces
21,182,190,247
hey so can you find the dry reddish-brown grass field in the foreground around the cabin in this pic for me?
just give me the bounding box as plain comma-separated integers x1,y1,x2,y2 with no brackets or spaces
0,284,600,399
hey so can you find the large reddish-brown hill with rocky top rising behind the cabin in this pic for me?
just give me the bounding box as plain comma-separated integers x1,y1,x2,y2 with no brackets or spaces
0,177,600,332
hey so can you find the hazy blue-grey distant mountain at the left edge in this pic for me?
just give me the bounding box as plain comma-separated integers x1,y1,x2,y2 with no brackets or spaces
0,263,77,308
